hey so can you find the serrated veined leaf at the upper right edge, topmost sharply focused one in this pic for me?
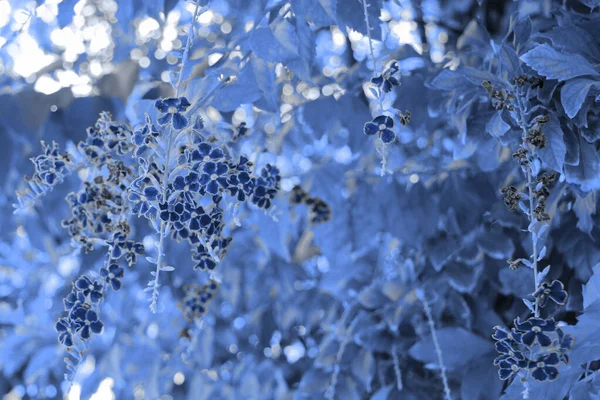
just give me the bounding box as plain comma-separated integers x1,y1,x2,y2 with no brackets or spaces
521,43,599,81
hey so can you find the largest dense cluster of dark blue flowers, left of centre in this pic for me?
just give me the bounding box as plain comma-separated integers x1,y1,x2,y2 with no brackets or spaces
128,97,281,271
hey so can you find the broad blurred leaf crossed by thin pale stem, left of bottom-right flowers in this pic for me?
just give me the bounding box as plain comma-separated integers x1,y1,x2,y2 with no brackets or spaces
408,327,493,371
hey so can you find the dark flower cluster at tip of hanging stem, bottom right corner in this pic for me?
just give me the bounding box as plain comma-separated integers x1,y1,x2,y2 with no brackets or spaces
492,316,574,381
